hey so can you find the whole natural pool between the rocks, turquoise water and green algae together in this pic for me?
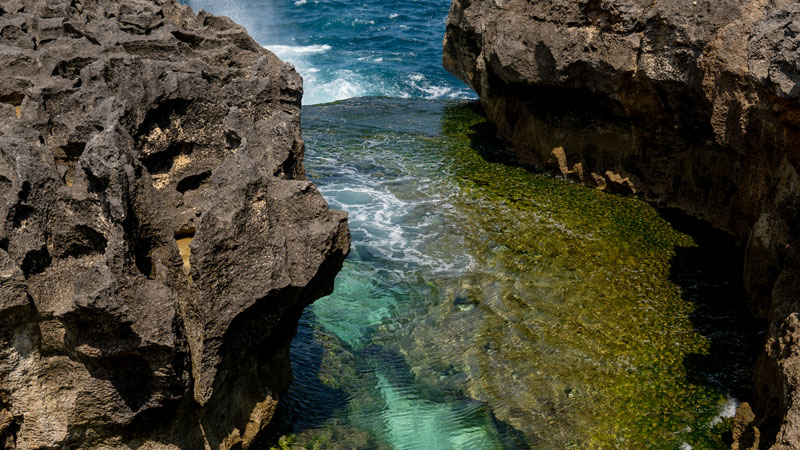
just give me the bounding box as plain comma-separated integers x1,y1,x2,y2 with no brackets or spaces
267,98,756,450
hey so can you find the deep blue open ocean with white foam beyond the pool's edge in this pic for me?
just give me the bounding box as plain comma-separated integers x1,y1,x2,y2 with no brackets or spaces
185,0,474,105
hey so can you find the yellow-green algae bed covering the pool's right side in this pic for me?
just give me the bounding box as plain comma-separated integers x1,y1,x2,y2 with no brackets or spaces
394,106,725,448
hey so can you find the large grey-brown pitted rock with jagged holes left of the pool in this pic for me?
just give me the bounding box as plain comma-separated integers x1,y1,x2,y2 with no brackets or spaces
0,0,350,449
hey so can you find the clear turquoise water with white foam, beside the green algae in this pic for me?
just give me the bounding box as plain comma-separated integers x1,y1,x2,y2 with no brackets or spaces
286,99,504,450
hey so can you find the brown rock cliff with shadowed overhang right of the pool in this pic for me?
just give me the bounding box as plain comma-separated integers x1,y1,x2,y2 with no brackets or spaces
443,0,800,448
